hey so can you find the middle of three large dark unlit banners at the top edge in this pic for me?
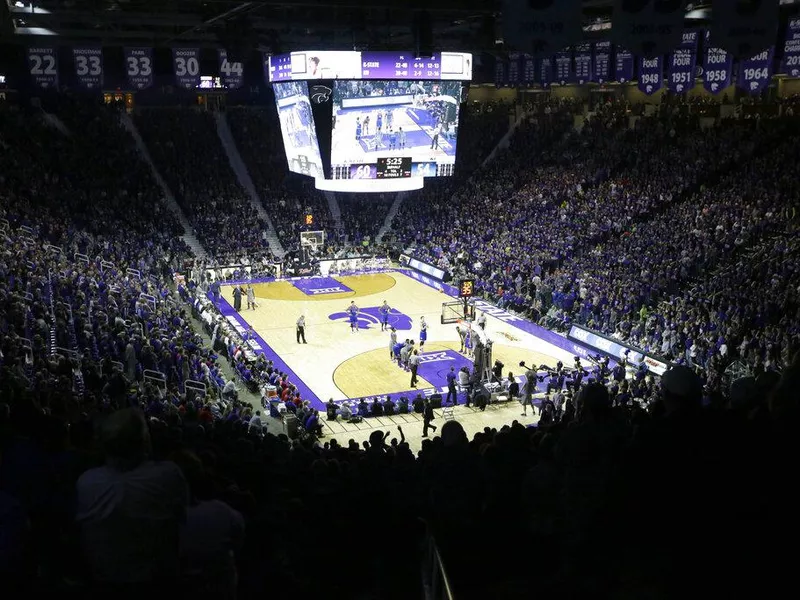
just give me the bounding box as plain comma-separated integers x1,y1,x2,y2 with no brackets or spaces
611,0,684,58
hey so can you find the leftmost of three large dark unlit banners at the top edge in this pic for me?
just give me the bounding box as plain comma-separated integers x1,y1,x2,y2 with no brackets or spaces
503,0,583,58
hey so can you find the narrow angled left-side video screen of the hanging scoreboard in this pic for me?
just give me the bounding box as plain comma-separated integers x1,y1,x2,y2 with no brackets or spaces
272,81,324,177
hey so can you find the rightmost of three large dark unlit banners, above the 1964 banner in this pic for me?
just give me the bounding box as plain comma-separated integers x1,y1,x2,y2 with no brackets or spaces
711,0,778,59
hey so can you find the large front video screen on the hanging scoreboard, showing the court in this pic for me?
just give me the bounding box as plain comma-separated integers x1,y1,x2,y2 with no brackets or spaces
331,81,462,177
